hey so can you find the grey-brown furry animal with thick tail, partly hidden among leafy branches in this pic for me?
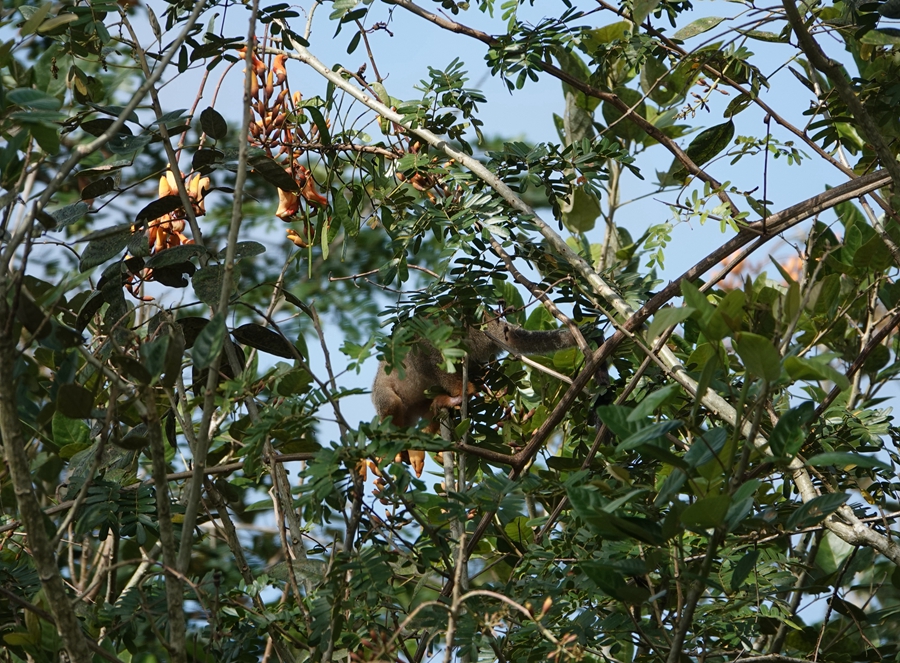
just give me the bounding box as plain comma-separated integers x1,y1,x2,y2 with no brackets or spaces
372,318,576,476
